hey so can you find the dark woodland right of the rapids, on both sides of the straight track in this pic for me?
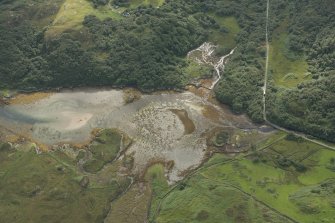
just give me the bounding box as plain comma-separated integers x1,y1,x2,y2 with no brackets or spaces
215,0,335,142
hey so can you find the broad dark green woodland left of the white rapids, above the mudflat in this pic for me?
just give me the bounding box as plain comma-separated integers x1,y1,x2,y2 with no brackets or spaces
0,1,210,90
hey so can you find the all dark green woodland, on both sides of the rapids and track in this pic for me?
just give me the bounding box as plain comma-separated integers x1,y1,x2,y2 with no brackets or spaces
0,0,335,141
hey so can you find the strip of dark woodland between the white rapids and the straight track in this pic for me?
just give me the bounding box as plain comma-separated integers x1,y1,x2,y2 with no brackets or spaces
215,0,272,122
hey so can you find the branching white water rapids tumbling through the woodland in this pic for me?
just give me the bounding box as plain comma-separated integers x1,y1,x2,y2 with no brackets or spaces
187,42,236,90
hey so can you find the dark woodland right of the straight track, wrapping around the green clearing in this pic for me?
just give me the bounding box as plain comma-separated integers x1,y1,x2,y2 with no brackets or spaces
267,0,335,142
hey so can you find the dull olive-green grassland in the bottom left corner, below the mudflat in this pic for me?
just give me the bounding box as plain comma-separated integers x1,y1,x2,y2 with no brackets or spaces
0,151,124,222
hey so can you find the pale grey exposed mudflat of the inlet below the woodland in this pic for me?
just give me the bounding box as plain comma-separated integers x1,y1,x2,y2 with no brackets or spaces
0,90,268,181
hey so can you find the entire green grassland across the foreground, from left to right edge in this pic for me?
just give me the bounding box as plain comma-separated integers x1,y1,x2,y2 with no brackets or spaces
0,130,335,223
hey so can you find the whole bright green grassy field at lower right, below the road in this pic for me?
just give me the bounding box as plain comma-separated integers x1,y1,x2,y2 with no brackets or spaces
156,133,335,222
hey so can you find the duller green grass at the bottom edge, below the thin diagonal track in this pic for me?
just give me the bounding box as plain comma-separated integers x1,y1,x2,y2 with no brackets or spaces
156,174,287,223
